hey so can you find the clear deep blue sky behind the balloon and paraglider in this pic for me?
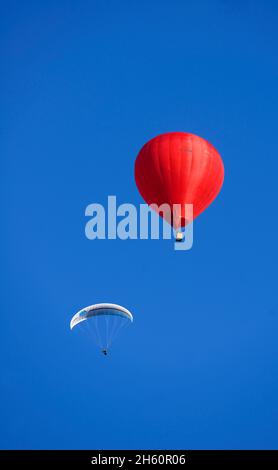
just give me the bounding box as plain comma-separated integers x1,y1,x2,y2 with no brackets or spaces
0,0,278,449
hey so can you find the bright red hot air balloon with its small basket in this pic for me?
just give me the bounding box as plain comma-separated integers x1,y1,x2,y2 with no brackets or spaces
135,132,224,239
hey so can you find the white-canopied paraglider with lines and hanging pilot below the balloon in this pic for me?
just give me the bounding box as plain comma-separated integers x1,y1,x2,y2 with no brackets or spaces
70,303,133,356
